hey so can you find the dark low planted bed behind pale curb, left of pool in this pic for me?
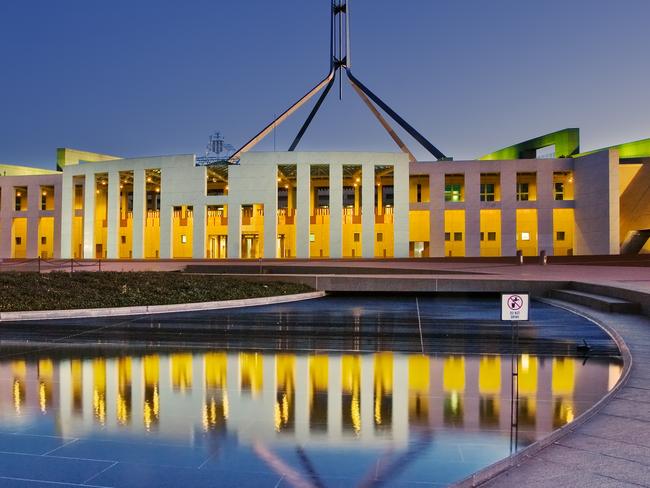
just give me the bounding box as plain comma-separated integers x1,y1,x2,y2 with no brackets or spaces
0,272,313,312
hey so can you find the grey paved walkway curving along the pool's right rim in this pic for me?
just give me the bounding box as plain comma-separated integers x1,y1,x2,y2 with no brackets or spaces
482,306,650,488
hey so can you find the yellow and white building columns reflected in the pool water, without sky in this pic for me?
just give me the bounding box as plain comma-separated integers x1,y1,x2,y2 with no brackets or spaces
0,352,621,446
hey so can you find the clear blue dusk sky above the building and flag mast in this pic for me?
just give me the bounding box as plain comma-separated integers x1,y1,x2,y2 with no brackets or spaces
0,0,650,167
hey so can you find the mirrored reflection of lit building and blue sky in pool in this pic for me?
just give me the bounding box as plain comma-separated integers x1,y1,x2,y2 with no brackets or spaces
0,350,621,486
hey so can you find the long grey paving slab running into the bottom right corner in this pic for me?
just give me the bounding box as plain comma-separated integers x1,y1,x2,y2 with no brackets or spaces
539,444,650,486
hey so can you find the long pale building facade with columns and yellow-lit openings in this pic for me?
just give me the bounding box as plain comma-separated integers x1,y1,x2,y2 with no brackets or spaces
0,129,650,259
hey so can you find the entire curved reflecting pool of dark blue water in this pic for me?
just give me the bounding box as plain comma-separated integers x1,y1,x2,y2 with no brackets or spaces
0,296,621,486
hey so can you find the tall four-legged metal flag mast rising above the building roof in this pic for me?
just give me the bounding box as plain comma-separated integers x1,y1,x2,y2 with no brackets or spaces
229,0,450,163
